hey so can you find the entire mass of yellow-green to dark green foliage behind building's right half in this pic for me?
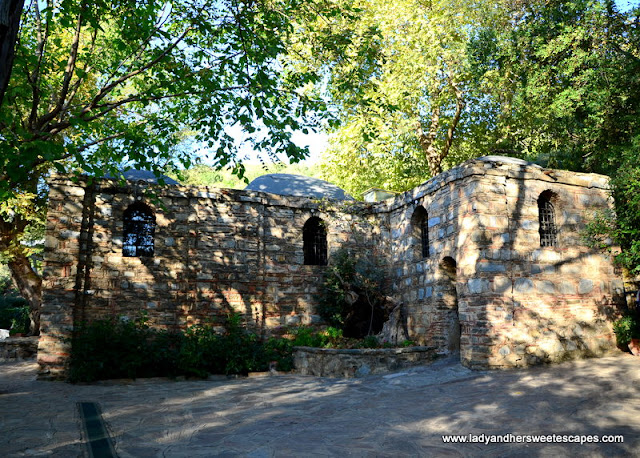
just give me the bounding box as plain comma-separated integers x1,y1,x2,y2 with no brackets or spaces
302,0,640,199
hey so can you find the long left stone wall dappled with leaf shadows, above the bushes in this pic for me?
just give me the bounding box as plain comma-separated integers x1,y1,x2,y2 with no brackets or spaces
39,178,377,377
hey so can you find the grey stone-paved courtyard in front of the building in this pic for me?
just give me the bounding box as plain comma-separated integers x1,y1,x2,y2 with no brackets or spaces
0,353,640,458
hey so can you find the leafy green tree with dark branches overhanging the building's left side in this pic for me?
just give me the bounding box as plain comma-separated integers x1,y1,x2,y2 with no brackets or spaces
0,0,322,331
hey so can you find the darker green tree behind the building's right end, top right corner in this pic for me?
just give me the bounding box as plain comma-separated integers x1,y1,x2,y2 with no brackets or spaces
470,0,640,174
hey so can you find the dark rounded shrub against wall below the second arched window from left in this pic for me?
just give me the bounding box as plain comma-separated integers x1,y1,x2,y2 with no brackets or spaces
318,249,390,338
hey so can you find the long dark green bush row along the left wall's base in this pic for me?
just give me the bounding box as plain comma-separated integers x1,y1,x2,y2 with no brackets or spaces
70,314,293,382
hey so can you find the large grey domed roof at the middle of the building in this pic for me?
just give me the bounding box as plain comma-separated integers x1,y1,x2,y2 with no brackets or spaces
245,173,353,200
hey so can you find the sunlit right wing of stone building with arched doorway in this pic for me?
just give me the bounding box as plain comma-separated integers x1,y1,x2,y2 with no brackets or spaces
385,158,623,368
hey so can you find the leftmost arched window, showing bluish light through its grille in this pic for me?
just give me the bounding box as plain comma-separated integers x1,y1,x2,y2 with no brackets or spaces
122,202,156,257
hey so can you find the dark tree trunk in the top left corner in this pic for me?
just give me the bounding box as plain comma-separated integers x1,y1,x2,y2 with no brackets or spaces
0,0,24,107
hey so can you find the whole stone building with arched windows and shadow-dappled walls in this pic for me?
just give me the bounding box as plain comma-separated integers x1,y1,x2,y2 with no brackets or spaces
38,156,624,377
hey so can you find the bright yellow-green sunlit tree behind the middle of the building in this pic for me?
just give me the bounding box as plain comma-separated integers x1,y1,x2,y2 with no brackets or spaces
292,0,498,194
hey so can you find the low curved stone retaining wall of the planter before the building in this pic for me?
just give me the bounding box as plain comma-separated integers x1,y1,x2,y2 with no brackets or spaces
293,347,437,377
